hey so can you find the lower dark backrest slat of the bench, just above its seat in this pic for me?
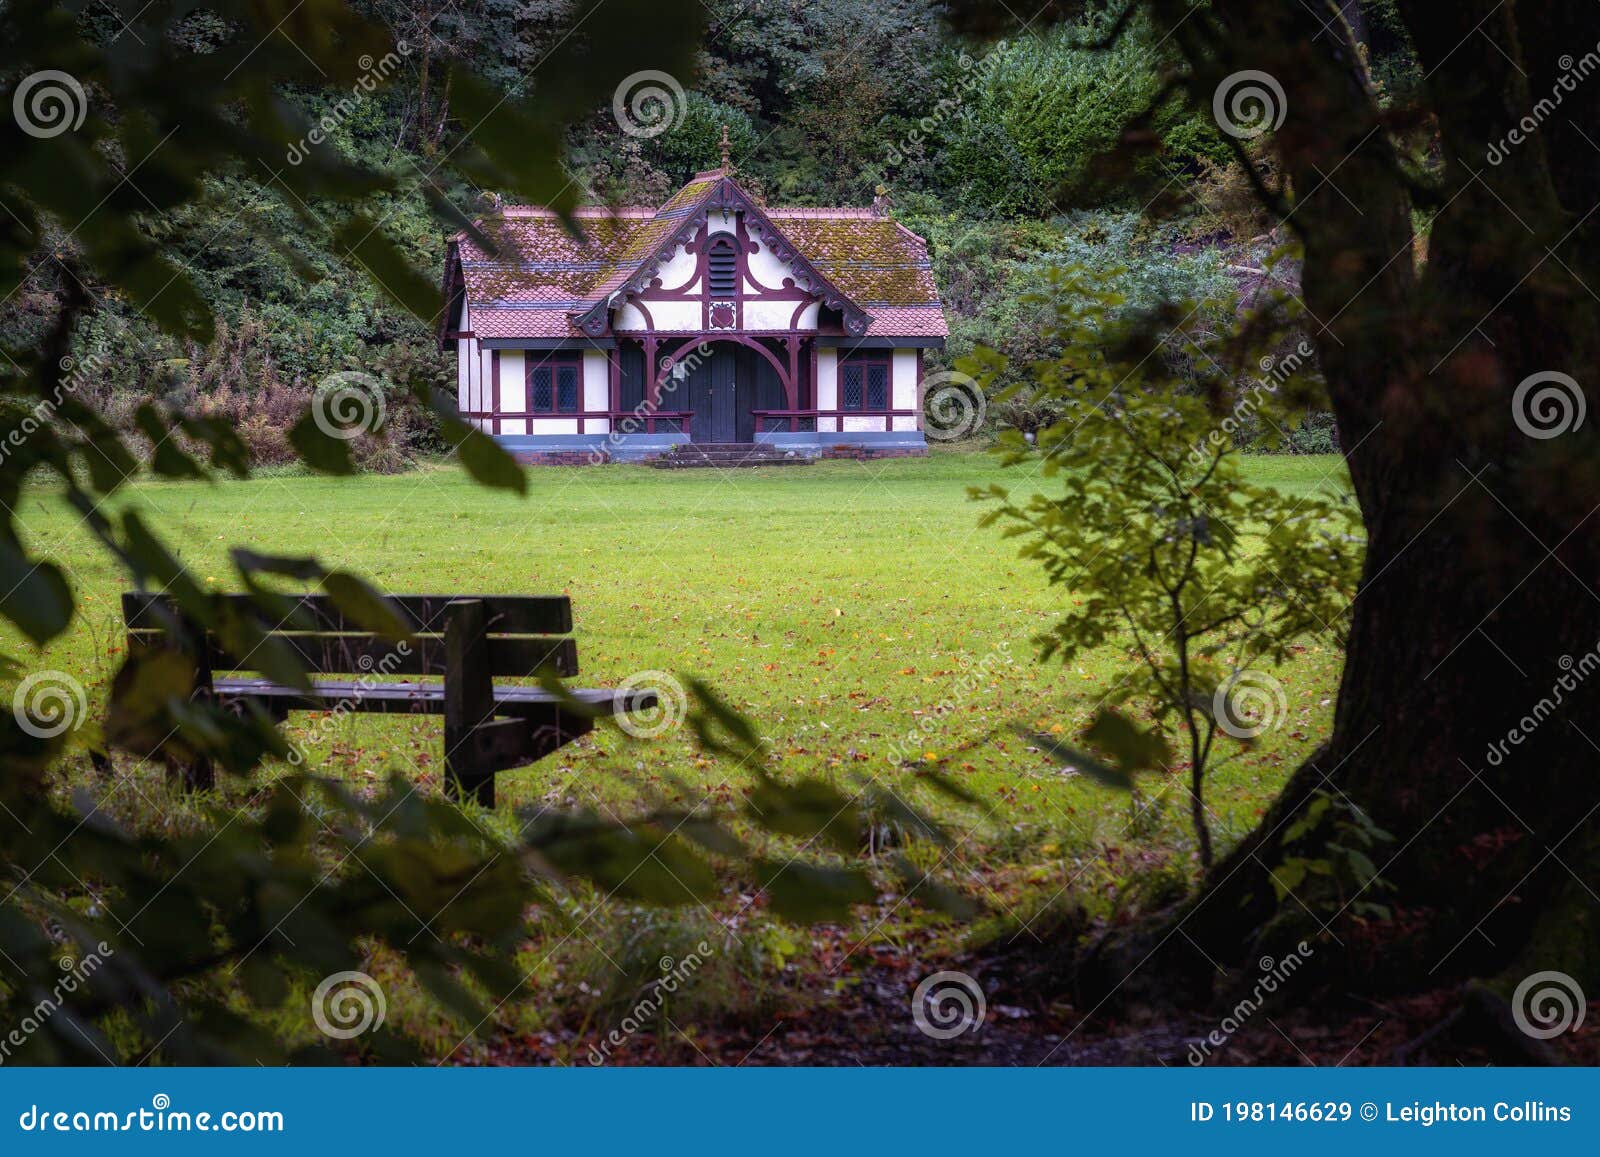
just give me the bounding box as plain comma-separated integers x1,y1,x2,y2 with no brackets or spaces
128,629,578,679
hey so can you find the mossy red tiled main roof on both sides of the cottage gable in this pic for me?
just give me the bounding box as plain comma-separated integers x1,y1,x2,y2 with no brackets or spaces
456,170,949,338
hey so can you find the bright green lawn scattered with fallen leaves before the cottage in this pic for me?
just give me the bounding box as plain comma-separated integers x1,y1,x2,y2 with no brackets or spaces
9,453,1346,1062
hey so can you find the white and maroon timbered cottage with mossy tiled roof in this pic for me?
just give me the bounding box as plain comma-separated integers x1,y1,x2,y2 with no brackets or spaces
440,158,949,462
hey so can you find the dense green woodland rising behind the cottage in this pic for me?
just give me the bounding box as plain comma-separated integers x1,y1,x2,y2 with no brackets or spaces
0,0,1418,469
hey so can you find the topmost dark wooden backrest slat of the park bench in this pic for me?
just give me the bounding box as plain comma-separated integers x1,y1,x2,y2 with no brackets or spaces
122,591,573,635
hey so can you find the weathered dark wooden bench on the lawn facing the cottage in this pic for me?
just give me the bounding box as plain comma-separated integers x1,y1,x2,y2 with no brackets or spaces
122,592,656,807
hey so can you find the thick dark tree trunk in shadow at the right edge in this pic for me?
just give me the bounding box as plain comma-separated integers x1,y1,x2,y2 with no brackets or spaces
1099,0,1600,991
